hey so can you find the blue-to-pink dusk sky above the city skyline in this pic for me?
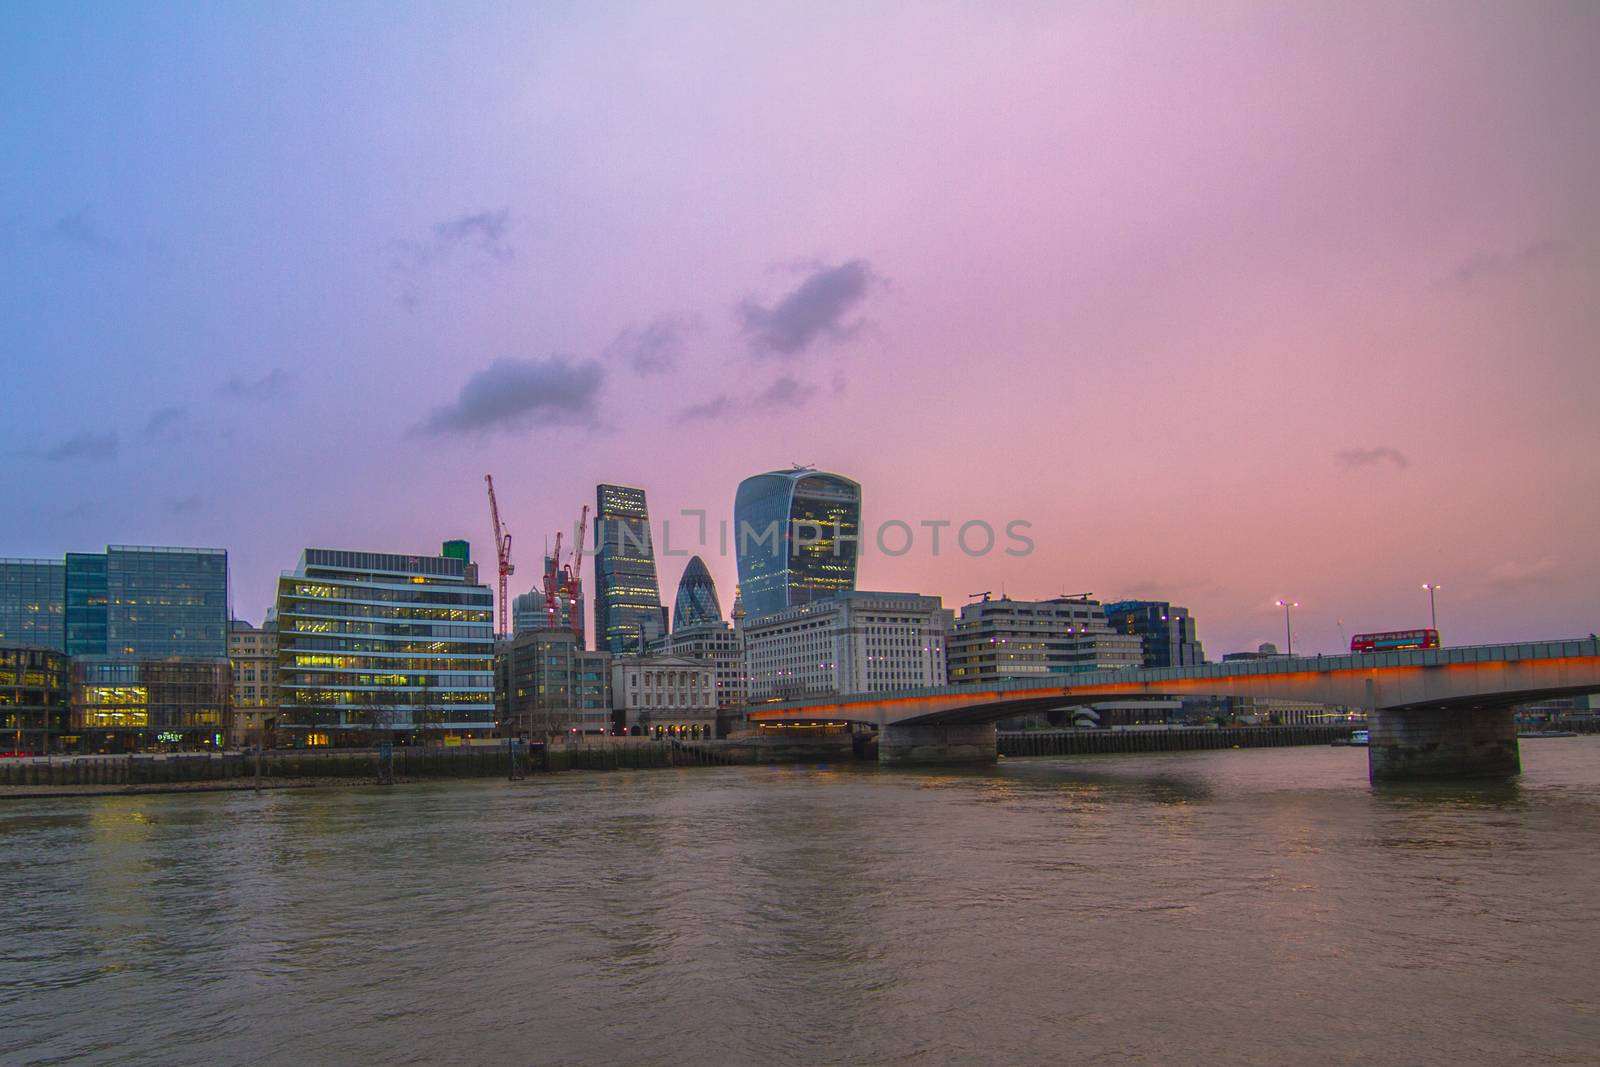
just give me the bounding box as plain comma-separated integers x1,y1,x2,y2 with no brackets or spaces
0,2,1600,657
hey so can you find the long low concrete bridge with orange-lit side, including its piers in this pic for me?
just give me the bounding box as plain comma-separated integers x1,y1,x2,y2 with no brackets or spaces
750,637,1600,781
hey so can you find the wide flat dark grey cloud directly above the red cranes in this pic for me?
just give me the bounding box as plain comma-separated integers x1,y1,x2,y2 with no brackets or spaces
411,355,605,435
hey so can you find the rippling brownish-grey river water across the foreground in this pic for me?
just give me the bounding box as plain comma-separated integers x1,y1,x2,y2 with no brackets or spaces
9,739,1600,1067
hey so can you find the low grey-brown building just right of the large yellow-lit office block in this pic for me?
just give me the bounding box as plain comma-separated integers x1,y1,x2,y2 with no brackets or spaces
494,630,611,741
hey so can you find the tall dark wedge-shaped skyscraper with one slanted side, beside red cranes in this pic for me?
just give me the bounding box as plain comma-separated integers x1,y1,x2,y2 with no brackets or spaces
594,485,667,653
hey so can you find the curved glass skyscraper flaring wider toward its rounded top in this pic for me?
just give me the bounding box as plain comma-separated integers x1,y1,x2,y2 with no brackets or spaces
733,467,861,616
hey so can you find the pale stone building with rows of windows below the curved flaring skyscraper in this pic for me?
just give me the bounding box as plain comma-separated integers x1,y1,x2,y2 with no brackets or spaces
742,590,952,702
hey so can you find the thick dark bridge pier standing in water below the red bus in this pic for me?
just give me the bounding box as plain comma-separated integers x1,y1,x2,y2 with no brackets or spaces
1366,707,1522,782
